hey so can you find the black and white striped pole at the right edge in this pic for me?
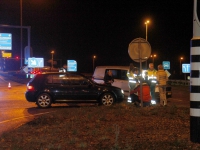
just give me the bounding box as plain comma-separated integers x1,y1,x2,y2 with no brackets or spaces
190,0,200,143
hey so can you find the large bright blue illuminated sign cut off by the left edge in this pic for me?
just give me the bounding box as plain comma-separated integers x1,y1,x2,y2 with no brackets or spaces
0,33,12,50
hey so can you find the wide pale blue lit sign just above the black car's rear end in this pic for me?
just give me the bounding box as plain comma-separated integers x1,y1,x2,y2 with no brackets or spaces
28,57,44,68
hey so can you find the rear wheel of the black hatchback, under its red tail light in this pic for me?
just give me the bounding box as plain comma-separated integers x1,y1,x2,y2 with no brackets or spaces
36,93,52,108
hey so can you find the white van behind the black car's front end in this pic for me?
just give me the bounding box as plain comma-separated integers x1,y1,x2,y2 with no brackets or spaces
92,66,129,96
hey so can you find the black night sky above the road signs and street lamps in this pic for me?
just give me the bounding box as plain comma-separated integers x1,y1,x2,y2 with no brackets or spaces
0,0,193,72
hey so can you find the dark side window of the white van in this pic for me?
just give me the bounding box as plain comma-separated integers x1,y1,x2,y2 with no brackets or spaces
105,69,128,80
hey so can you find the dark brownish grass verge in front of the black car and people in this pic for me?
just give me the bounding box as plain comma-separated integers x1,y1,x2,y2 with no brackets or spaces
0,103,200,150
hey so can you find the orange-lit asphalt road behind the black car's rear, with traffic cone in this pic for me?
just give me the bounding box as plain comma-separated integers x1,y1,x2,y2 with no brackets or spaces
0,76,55,135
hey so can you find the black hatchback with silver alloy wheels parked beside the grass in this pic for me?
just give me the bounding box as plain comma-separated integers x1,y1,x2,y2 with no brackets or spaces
25,72,124,108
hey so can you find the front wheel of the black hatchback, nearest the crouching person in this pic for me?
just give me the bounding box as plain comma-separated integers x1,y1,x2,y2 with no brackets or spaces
101,93,115,106
